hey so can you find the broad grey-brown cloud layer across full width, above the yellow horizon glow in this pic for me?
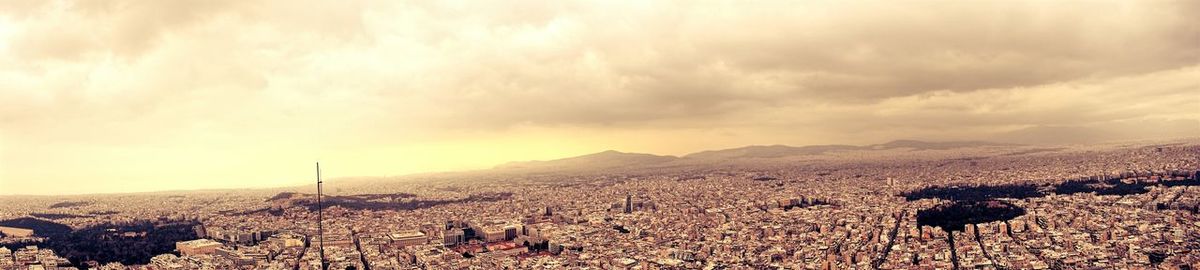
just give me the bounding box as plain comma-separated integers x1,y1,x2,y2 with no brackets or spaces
8,1,1200,126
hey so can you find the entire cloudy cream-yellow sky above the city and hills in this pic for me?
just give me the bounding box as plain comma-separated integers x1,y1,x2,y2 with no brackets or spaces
0,0,1200,194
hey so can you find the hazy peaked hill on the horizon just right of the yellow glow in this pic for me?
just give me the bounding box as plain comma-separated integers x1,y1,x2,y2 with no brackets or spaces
496,150,679,170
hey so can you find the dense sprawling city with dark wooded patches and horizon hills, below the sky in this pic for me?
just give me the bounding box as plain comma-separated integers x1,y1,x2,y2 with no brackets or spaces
0,139,1200,270
